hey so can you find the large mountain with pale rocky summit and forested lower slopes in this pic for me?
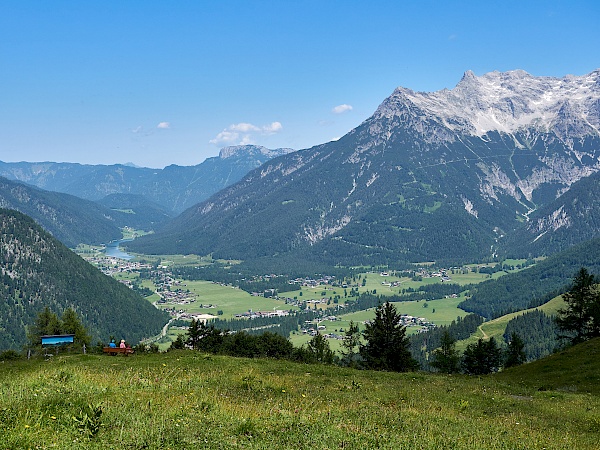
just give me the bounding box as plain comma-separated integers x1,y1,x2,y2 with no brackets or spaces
131,70,600,265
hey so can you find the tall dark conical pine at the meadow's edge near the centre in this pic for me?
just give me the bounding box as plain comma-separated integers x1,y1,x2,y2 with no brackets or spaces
360,302,418,372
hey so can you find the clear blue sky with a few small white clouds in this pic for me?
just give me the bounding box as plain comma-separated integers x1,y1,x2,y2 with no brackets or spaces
0,0,600,167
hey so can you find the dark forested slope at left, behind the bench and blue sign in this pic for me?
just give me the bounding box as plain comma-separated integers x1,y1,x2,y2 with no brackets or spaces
0,209,168,349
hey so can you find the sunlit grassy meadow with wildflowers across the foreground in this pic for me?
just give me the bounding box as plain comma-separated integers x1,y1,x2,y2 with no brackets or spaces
0,340,600,449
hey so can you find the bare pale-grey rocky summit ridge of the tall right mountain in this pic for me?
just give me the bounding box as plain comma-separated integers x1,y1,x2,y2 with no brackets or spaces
373,69,600,141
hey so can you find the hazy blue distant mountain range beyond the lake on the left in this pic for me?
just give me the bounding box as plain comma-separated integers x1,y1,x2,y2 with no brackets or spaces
0,145,292,216
